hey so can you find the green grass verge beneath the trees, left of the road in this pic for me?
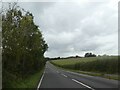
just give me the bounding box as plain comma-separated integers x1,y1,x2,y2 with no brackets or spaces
3,68,44,90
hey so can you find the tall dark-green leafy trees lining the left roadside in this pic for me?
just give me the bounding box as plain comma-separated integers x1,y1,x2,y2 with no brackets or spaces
2,5,48,88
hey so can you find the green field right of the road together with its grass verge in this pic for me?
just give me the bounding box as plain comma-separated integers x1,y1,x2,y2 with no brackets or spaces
50,56,120,80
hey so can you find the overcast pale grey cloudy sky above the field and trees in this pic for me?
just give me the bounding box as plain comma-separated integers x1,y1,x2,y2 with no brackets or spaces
1,0,118,57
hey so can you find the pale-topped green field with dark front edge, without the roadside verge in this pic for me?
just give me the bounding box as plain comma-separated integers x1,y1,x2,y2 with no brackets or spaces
51,56,120,74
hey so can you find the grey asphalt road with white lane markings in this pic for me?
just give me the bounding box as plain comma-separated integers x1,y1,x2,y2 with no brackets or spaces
38,62,118,90
